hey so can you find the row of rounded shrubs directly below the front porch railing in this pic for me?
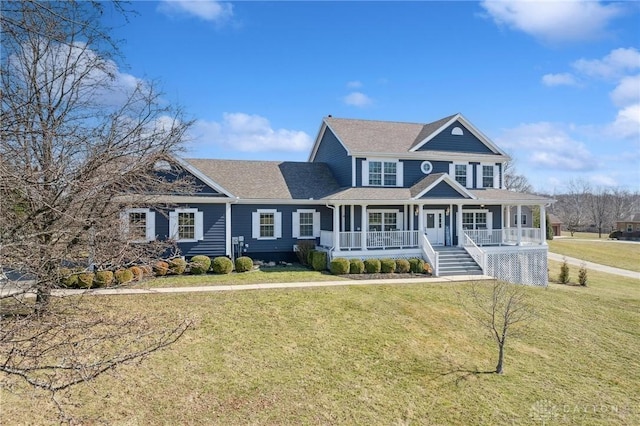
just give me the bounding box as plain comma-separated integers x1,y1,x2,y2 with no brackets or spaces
328,252,431,275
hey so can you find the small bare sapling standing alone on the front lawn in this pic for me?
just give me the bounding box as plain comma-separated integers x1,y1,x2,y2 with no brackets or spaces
461,280,535,374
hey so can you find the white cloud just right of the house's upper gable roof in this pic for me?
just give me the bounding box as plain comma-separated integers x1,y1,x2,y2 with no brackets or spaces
498,122,597,171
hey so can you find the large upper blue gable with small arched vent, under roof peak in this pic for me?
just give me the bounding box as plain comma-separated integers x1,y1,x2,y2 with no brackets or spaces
417,120,495,154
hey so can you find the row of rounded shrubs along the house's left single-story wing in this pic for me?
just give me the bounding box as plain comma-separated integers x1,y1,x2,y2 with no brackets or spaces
58,255,253,288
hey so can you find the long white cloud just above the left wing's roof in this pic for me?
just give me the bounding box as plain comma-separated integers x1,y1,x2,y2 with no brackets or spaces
191,112,313,152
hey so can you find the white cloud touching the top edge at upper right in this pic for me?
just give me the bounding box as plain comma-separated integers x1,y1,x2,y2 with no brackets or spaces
481,0,622,42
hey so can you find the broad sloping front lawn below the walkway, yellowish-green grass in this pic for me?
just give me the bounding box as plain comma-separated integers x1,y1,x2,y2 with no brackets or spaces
0,262,640,425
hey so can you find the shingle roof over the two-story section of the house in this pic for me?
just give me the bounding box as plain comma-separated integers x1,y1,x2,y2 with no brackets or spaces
324,114,455,153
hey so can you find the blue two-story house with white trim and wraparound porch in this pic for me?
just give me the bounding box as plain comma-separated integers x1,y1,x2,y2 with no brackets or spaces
124,114,553,285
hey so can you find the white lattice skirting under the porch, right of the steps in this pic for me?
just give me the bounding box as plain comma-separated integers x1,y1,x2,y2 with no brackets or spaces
485,247,549,287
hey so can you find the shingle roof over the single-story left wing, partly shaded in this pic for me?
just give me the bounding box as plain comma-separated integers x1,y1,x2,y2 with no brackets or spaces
185,158,339,200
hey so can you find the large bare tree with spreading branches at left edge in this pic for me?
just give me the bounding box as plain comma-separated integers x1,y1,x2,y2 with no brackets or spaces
0,1,191,418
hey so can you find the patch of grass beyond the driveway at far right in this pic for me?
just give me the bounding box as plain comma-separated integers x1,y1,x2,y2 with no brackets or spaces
548,238,640,272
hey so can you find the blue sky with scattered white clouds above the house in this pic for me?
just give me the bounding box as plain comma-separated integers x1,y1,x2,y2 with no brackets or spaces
107,0,640,193
